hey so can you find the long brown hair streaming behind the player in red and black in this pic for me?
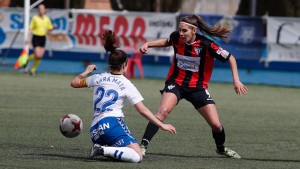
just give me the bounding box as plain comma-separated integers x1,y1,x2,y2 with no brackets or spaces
180,15,231,42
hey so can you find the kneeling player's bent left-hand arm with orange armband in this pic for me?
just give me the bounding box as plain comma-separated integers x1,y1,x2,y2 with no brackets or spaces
70,65,97,88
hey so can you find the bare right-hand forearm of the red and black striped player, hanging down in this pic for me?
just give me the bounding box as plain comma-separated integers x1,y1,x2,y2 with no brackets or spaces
228,55,248,96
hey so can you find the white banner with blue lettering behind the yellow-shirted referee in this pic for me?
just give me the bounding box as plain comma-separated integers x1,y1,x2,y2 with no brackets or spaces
0,8,72,49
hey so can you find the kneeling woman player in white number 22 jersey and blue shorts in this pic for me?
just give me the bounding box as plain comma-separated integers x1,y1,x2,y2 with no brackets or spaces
71,30,176,163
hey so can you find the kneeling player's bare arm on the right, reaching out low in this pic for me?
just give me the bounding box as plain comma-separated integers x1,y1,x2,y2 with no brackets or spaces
134,102,176,134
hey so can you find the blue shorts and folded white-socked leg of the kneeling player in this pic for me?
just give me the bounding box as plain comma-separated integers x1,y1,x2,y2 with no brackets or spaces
89,117,142,163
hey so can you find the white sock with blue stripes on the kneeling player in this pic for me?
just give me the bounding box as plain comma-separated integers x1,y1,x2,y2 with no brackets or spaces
102,147,141,163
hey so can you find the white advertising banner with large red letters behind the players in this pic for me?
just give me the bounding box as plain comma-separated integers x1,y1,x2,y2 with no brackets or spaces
70,10,177,56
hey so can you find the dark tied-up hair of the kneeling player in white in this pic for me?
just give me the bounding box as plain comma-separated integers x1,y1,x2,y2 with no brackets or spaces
100,30,127,70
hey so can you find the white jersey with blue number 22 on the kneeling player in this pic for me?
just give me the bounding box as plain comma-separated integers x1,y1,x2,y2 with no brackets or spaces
86,72,144,125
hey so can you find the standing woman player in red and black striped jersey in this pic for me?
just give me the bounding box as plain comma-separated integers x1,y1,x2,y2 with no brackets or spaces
140,15,248,158
